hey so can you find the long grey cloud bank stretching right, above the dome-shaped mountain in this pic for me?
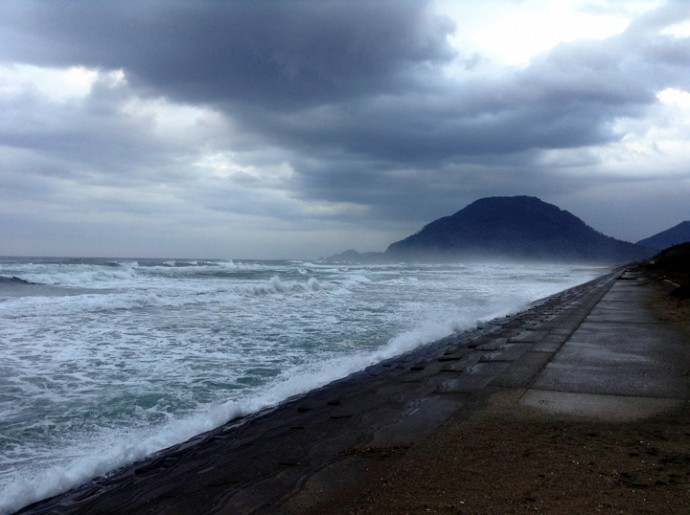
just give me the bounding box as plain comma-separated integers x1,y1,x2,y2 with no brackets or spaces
212,4,690,175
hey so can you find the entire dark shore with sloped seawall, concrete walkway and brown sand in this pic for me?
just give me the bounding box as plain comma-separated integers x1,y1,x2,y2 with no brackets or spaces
17,272,690,513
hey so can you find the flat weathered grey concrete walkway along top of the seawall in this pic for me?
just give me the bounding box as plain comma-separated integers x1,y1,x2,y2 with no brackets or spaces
521,272,690,420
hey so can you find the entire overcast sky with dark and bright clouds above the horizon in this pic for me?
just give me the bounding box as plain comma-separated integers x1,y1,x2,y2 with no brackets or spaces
0,0,690,259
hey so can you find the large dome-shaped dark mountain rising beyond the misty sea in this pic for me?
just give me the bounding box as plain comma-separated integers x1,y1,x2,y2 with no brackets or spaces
385,196,652,263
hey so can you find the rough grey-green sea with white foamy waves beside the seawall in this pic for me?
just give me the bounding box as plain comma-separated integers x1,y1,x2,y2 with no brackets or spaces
0,258,603,513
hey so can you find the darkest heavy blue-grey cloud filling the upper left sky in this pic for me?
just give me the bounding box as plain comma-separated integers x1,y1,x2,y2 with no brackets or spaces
3,0,453,110
